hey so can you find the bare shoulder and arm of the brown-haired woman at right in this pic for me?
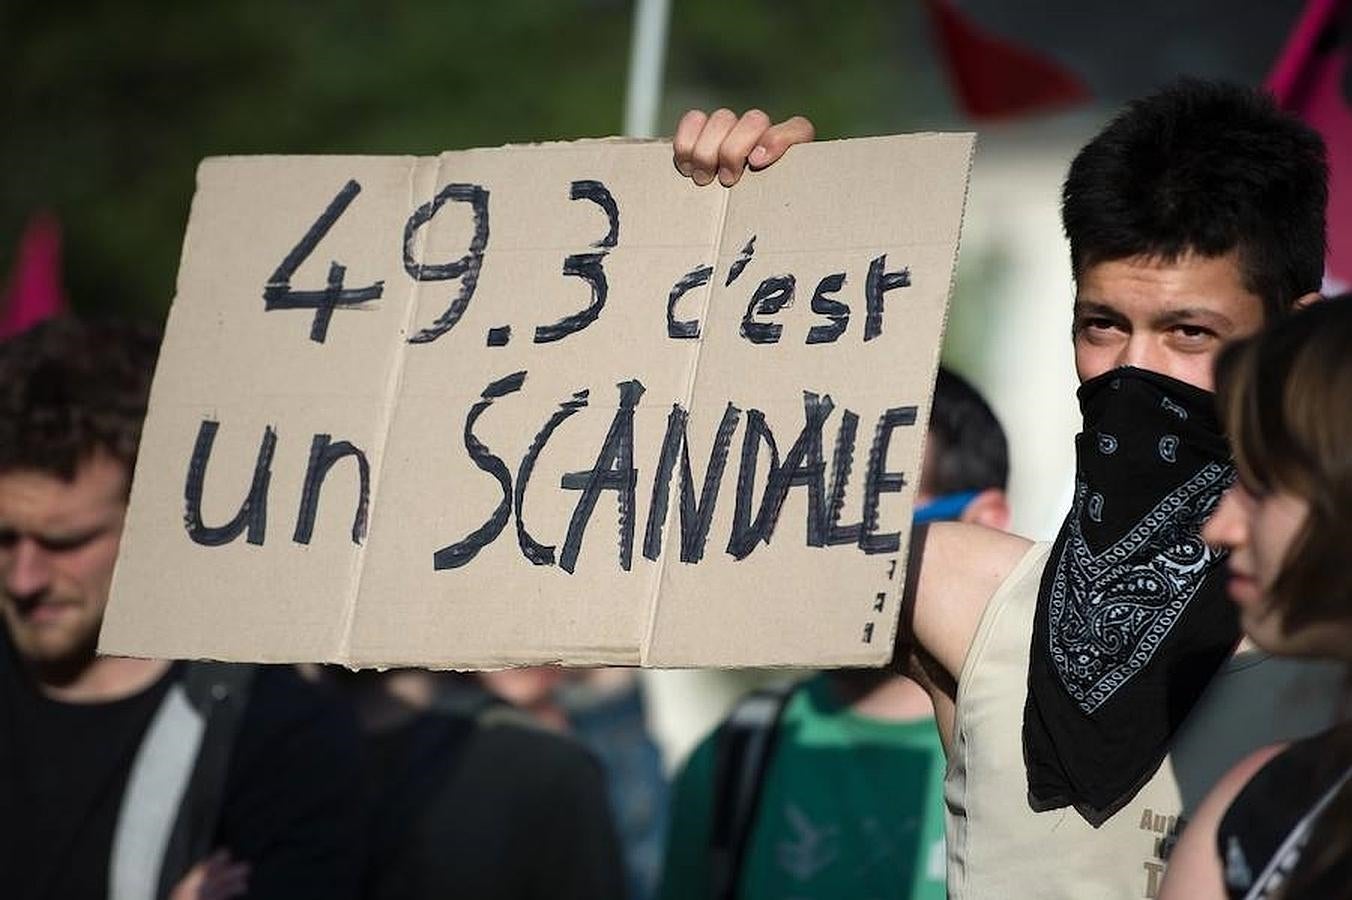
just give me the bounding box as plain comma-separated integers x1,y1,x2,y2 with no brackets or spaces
1159,745,1284,900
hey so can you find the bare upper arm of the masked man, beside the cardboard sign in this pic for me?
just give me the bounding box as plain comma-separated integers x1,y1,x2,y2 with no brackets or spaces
910,522,1033,678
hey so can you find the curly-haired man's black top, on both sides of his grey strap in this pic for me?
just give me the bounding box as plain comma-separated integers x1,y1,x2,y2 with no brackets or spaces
0,627,364,900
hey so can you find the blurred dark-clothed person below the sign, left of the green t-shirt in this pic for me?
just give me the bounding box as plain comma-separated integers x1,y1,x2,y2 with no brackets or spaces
326,669,625,900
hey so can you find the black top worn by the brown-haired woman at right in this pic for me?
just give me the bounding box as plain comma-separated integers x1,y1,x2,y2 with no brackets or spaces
1215,726,1352,900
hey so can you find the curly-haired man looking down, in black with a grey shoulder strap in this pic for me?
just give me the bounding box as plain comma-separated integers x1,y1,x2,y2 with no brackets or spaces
0,318,362,900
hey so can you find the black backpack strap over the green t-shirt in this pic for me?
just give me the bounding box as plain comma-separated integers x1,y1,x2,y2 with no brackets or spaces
708,682,798,900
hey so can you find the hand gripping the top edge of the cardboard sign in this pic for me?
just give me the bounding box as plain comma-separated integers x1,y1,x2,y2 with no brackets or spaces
672,109,817,188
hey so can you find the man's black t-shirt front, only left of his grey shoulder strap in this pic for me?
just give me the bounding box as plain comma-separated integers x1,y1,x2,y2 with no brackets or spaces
0,637,174,900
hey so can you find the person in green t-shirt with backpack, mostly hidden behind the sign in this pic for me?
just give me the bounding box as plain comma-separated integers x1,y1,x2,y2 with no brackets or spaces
661,369,1009,900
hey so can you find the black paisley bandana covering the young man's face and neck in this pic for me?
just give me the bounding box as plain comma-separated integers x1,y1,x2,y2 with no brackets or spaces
1023,369,1240,826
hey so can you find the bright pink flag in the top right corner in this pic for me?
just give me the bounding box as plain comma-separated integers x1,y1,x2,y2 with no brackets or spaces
1267,0,1352,293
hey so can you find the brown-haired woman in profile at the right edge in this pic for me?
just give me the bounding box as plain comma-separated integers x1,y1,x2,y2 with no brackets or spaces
1160,295,1352,900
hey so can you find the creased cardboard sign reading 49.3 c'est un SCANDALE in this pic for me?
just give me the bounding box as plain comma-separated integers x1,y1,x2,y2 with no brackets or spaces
100,134,972,668
